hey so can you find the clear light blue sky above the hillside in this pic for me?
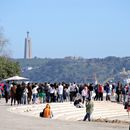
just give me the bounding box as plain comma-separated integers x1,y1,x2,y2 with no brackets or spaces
0,0,130,58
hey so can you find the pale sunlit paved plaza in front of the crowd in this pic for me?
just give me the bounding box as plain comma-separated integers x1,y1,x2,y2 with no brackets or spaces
0,98,129,130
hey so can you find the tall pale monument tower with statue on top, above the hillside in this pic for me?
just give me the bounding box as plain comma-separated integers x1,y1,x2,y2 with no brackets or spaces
24,32,32,59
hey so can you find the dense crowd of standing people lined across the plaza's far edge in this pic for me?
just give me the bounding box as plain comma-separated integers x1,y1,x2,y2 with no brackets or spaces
0,81,130,105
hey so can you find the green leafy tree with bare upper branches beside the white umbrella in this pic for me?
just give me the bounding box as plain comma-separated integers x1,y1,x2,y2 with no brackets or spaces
0,28,20,80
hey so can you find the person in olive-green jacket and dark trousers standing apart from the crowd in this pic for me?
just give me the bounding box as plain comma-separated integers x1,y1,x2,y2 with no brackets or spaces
83,98,94,121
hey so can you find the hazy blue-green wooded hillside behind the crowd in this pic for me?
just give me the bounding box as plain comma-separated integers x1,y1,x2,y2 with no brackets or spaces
17,57,130,83
